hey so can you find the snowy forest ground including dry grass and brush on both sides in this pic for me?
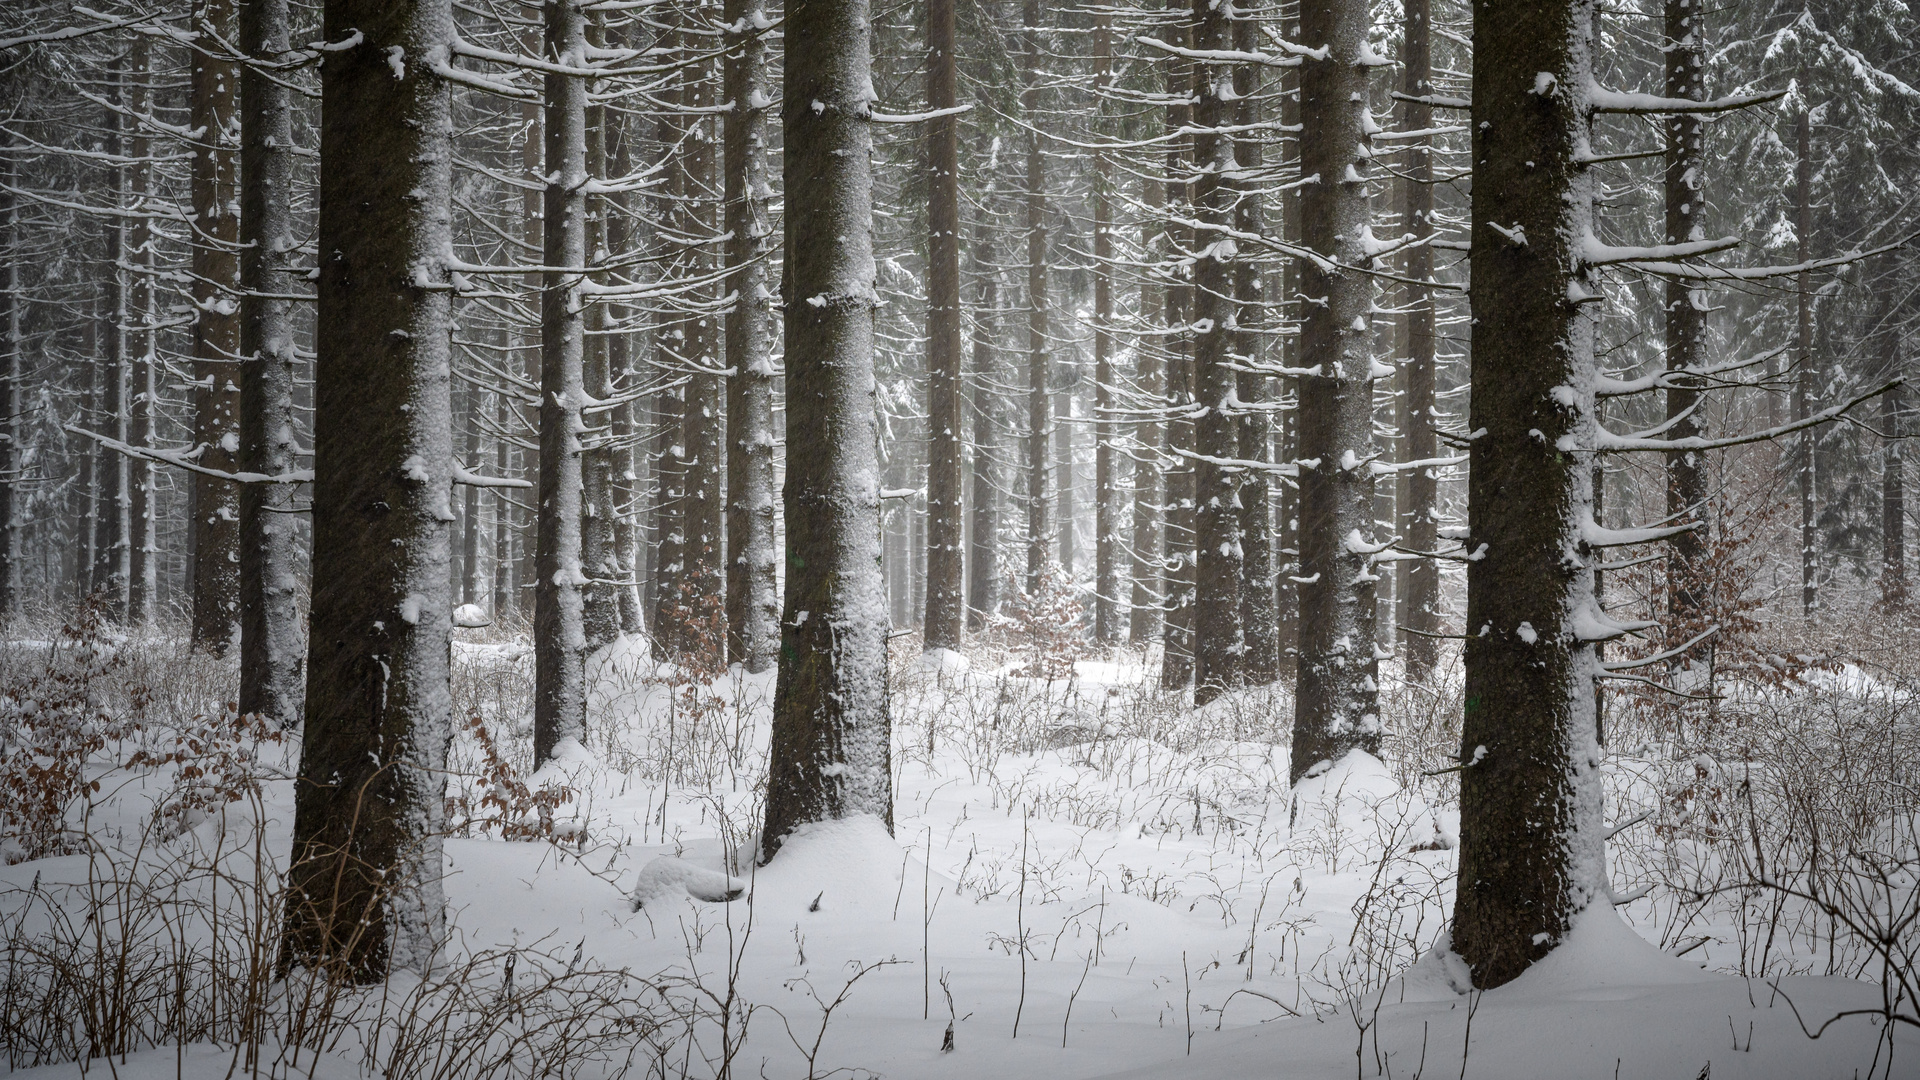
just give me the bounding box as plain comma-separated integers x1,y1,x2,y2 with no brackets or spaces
0,618,1920,1080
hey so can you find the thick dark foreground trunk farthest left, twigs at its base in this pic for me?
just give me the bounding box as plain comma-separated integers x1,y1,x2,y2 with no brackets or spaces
282,0,453,982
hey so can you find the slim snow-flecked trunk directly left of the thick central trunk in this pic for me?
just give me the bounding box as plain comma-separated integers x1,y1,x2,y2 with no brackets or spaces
726,0,775,673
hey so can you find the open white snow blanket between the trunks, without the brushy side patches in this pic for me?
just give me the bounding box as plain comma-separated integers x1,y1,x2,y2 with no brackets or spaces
0,630,1920,1080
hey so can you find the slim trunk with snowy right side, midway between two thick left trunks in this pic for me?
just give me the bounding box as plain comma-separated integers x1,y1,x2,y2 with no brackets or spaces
534,0,588,767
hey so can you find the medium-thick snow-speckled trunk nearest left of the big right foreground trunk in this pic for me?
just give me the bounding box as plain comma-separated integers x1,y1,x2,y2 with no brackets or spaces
1290,0,1384,782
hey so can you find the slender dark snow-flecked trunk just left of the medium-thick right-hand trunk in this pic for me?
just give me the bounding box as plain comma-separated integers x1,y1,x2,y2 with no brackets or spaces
1190,0,1246,705
